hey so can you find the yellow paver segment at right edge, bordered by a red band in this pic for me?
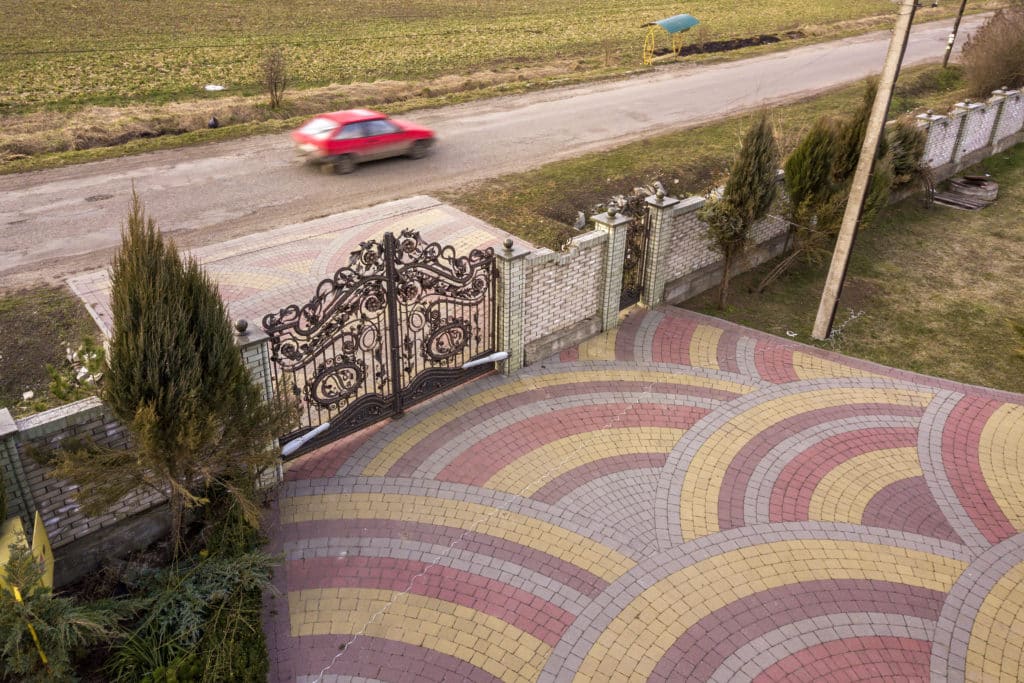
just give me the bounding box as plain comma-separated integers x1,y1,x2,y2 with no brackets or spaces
978,403,1024,531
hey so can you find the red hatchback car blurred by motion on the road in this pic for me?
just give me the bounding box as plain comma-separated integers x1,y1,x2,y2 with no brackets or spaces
292,110,434,173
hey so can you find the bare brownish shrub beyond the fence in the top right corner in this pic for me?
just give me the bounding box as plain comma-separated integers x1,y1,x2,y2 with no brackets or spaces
961,4,1024,97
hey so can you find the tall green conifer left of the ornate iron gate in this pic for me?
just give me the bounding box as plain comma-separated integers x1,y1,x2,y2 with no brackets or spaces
56,191,294,556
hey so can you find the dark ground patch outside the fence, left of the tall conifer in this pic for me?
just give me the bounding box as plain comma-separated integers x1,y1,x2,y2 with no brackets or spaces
0,287,100,415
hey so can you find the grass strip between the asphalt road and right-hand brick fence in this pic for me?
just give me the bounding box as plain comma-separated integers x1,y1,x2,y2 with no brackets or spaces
439,66,964,251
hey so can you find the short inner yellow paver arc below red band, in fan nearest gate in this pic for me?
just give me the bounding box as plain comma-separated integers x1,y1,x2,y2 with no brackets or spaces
483,427,686,498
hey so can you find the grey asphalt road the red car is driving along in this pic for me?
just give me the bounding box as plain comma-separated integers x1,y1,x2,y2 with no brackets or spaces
0,16,983,289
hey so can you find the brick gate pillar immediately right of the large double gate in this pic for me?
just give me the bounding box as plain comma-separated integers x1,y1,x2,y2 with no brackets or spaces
495,238,530,375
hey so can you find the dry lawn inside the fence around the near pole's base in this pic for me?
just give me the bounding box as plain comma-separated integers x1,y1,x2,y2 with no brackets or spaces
681,144,1024,393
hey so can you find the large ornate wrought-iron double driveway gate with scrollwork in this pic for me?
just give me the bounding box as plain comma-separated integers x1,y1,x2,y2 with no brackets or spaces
263,230,496,456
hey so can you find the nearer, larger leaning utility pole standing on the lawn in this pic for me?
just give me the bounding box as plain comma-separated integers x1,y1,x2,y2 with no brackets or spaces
811,0,918,340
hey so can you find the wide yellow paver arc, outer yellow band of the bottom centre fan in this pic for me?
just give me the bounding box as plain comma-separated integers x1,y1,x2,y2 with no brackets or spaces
580,540,967,679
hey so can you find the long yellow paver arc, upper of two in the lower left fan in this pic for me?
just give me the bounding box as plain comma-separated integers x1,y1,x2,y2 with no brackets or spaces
281,494,636,582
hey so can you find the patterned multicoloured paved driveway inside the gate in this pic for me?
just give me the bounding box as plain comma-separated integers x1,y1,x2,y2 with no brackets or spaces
266,308,1024,683
